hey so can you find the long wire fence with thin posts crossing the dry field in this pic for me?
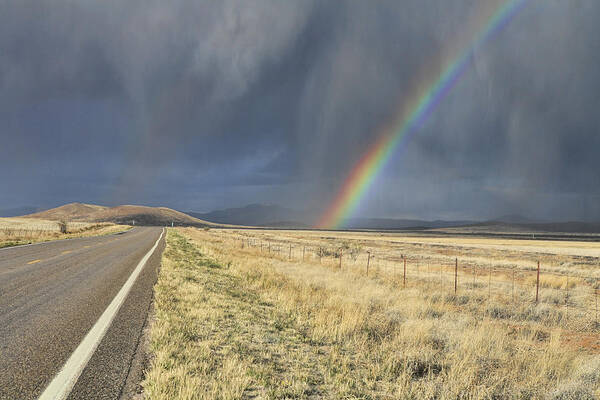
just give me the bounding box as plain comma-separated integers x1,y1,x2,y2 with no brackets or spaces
238,237,600,331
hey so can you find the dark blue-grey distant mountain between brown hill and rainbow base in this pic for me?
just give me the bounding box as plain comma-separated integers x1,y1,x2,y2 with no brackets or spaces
187,204,309,228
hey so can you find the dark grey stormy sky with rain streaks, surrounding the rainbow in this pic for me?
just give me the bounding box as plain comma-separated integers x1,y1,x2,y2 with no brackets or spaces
0,0,600,221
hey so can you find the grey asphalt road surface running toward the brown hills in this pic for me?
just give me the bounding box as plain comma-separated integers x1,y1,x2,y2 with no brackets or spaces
0,227,164,400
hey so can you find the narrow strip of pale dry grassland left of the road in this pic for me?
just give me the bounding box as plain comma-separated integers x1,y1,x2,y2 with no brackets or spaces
0,218,130,248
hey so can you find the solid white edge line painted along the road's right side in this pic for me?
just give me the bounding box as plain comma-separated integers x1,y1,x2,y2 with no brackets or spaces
39,228,165,400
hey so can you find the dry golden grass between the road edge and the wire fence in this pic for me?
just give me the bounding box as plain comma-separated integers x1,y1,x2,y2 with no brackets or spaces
144,229,600,399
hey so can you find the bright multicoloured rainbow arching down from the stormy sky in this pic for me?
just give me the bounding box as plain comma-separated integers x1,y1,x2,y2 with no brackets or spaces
315,0,527,229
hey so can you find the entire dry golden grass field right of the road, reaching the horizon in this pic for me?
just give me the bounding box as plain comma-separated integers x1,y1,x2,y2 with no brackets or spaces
144,228,600,399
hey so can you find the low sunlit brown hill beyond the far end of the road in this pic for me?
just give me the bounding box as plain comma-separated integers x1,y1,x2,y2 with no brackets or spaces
25,203,217,226
